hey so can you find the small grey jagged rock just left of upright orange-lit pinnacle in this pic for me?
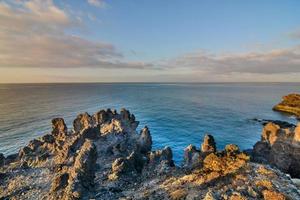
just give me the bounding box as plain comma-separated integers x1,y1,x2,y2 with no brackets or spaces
184,144,202,168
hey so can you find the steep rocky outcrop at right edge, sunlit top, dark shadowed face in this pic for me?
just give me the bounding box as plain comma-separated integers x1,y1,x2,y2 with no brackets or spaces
253,123,300,178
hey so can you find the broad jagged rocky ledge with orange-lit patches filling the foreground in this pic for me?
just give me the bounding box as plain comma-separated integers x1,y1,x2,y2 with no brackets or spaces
0,109,300,200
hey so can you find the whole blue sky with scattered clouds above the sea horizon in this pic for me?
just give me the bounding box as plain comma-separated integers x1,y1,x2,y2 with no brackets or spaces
0,0,300,83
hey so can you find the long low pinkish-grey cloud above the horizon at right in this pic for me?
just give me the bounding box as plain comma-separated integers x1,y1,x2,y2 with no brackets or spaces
160,46,300,74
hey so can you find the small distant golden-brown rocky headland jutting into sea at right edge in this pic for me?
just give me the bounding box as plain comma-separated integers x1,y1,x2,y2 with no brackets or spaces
273,94,300,118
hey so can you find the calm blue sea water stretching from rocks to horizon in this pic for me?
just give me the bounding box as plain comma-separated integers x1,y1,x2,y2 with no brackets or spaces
0,83,300,162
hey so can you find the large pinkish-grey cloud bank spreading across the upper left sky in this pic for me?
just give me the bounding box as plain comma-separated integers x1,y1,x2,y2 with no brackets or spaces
0,0,149,69
